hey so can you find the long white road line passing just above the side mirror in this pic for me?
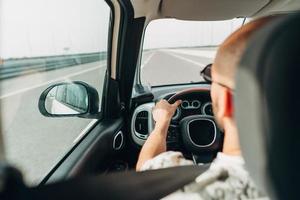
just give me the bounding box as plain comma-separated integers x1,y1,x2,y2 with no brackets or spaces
0,64,105,99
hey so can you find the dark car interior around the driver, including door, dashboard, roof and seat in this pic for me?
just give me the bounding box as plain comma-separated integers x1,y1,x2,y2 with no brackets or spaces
0,0,300,199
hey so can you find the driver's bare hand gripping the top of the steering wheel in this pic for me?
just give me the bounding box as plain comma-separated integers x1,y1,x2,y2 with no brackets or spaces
152,99,182,132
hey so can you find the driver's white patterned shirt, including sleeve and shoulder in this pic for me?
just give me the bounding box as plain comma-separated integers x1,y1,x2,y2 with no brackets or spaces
141,151,268,200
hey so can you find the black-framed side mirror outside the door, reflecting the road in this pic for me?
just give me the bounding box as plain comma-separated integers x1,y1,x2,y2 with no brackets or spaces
39,81,99,118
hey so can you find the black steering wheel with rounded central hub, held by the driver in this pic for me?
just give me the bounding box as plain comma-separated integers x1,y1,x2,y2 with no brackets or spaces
167,88,223,162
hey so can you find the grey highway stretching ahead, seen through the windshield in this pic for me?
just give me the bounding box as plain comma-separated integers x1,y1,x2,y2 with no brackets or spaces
141,49,215,86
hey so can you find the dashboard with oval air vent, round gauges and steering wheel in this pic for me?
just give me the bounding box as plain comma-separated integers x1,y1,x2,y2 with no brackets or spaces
131,84,222,162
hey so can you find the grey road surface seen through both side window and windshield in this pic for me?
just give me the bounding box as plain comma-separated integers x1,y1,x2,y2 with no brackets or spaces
0,49,215,184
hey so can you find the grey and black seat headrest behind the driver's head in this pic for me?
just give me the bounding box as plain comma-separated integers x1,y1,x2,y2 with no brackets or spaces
234,13,300,199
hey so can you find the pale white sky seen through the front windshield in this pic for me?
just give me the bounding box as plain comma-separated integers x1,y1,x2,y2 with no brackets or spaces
144,19,242,49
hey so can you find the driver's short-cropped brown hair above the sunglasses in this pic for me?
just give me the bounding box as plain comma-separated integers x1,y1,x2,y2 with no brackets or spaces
214,16,275,89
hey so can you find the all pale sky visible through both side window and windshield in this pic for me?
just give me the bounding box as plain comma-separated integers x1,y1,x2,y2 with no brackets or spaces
0,0,241,59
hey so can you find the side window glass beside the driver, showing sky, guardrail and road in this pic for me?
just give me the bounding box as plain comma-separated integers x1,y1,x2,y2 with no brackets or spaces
0,0,110,185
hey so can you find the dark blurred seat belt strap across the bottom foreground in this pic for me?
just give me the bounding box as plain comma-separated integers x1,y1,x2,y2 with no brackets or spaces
0,165,209,200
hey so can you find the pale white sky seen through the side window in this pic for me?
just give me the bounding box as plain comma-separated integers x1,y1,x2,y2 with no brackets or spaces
0,0,110,58
